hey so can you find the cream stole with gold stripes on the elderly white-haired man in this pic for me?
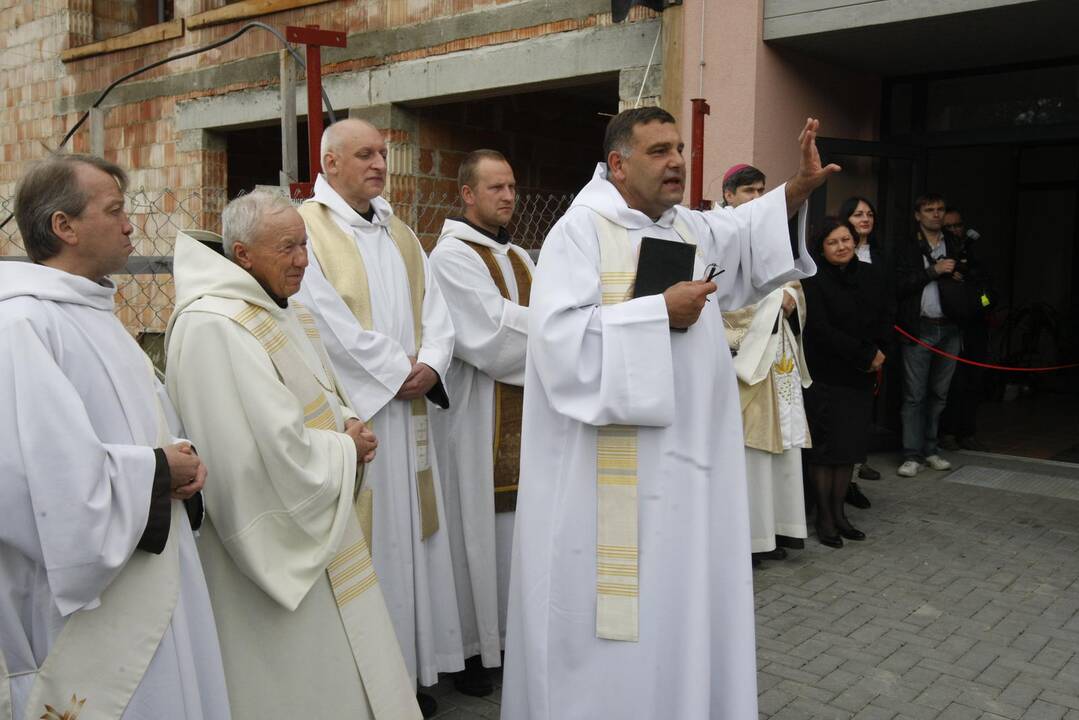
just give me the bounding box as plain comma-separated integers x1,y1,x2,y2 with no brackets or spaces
232,301,420,720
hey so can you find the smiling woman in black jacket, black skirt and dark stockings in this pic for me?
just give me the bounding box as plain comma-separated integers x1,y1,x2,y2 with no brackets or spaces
802,217,891,547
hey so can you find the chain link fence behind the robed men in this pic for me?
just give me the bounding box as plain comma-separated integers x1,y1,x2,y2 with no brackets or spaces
0,189,573,351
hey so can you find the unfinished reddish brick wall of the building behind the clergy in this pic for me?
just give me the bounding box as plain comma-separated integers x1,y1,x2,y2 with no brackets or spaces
0,0,653,331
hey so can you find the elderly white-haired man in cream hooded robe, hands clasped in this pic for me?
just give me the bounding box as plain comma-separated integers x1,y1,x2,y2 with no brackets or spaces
166,191,420,720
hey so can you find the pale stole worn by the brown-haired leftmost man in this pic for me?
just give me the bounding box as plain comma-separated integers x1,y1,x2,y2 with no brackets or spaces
19,369,180,720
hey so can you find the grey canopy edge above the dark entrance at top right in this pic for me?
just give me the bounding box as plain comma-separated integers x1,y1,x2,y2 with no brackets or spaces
763,0,1037,40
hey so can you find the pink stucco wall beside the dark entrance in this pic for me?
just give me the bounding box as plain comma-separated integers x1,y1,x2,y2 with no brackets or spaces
681,0,880,201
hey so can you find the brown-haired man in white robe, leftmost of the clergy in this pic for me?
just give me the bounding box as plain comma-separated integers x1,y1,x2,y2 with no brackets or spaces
0,154,229,720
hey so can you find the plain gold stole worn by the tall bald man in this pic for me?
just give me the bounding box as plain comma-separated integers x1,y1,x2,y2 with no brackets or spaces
300,200,438,540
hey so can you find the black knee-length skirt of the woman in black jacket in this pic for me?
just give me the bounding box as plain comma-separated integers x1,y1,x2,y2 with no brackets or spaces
805,381,873,465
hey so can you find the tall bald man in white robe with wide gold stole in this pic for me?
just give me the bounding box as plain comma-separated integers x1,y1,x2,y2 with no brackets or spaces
299,119,464,711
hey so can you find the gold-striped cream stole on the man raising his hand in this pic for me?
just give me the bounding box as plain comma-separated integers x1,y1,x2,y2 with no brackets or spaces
592,213,700,642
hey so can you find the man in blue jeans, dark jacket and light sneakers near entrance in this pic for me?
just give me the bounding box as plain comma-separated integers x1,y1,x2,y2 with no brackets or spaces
896,193,971,477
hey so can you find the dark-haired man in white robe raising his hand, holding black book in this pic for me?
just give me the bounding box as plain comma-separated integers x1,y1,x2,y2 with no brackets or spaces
502,108,837,720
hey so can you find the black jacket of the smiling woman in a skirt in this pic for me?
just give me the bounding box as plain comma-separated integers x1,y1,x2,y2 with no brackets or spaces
802,258,892,388
